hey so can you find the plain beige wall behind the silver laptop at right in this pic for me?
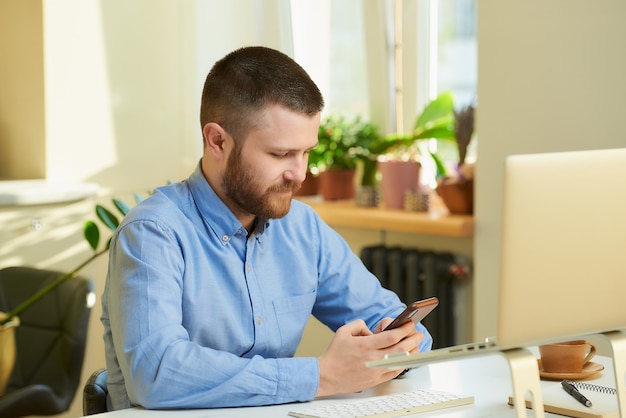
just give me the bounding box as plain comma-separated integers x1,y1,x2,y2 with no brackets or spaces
474,0,626,338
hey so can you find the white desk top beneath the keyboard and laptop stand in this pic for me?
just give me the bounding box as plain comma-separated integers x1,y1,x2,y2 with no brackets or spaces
97,354,612,418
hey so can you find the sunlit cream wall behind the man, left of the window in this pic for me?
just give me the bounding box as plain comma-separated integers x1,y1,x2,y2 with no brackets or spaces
0,0,289,417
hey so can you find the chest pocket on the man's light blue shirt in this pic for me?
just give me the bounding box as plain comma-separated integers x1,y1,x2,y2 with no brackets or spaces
273,292,316,357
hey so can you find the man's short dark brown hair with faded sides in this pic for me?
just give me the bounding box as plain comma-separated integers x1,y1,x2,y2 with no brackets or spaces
200,46,324,139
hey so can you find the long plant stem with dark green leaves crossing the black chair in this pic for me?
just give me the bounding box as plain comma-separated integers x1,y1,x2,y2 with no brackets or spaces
0,193,143,326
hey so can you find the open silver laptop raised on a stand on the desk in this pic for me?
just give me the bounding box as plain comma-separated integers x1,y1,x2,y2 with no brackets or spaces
367,148,626,368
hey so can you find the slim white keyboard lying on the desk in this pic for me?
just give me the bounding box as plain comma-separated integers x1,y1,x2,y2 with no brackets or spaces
289,390,474,418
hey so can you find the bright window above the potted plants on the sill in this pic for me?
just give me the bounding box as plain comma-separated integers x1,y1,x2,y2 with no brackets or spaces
291,0,477,173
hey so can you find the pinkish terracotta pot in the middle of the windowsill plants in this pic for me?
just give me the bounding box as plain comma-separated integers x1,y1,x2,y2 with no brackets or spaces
378,161,421,209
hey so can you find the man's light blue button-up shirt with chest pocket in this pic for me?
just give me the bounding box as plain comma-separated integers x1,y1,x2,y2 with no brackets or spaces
102,163,432,409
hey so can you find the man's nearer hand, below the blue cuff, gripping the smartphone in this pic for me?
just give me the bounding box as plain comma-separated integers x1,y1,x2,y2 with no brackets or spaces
317,320,424,396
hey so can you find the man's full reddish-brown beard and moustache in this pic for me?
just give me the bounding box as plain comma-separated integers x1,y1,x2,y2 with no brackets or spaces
222,147,302,219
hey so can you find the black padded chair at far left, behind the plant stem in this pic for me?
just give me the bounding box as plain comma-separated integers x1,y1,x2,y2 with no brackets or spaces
0,267,93,418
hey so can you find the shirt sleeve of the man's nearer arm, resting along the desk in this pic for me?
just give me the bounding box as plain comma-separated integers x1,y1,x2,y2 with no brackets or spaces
103,221,319,409
